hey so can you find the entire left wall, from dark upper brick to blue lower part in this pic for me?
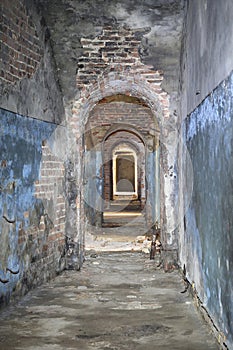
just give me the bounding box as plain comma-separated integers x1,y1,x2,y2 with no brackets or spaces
0,0,66,306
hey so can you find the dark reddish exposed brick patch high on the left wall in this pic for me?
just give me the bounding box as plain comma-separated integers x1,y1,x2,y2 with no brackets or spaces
0,0,42,83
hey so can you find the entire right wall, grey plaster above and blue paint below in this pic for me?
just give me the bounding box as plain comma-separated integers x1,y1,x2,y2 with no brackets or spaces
179,0,233,349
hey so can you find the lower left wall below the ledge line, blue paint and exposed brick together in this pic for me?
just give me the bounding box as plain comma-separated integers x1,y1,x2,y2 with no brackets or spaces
0,109,65,305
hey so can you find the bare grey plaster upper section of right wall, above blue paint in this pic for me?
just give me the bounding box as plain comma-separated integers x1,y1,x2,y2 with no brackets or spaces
181,0,233,116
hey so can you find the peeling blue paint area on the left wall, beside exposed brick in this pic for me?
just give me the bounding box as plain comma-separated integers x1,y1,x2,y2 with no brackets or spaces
0,109,56,305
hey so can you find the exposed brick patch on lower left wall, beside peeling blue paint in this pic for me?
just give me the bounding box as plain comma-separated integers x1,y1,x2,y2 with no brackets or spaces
18,141,66,291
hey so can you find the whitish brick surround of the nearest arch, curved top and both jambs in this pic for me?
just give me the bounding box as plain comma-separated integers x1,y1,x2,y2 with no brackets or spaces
68,64,176,270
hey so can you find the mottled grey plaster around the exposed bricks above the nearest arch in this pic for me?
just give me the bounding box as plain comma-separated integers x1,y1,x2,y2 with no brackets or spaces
36,0,183,113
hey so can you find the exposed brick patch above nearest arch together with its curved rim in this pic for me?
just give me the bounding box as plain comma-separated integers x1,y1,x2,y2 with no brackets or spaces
73,27,170,135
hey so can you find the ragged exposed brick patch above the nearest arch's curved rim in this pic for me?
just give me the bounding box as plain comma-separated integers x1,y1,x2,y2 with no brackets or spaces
77,27,163,92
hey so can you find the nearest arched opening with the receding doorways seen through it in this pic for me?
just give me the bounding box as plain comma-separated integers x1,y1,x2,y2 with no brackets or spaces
84,96,160,235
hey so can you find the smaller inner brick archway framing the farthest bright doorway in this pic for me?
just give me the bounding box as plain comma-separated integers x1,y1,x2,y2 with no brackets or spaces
102,131,146,208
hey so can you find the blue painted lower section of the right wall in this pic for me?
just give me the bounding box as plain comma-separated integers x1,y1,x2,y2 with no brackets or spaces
184,74,233,348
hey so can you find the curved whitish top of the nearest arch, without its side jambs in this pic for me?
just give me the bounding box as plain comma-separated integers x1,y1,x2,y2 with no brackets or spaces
70,65,169,131
